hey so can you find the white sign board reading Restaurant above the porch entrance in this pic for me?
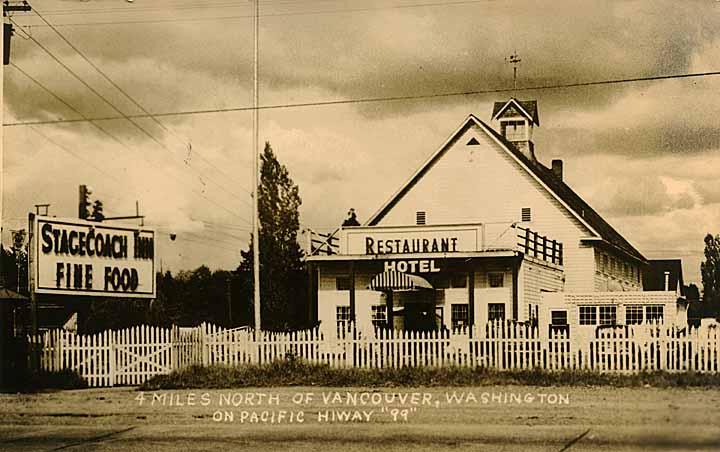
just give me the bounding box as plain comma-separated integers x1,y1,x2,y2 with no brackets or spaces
344,226,481,255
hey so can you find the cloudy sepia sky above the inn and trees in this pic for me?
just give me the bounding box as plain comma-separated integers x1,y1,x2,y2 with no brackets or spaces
2,0,720,283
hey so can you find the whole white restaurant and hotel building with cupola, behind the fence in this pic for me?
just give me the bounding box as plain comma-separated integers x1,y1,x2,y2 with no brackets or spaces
307,99,686,338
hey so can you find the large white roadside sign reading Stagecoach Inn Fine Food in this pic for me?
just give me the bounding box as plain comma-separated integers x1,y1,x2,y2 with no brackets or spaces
32,217,155,298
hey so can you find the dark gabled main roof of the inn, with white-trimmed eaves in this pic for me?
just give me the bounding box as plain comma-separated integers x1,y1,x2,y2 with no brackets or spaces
366,115,647,263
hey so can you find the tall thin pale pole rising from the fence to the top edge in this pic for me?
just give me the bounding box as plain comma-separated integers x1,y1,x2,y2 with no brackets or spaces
252,0,262,332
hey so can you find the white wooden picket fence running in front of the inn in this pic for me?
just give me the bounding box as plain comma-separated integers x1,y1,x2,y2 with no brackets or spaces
30,321,720,386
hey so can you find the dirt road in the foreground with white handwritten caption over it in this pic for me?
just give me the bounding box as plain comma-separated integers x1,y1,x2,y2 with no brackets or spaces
0,386,720,452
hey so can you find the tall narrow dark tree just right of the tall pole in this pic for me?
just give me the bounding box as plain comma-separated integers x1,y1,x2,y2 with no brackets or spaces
238,143,306,330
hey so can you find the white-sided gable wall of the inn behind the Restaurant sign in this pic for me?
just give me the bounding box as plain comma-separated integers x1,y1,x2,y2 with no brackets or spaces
378,126,595,291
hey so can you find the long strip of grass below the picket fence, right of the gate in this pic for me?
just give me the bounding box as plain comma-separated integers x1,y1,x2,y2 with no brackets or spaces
140,360,720,391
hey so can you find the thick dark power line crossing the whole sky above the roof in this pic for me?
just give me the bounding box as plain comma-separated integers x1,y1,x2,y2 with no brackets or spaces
3,71,720,127
